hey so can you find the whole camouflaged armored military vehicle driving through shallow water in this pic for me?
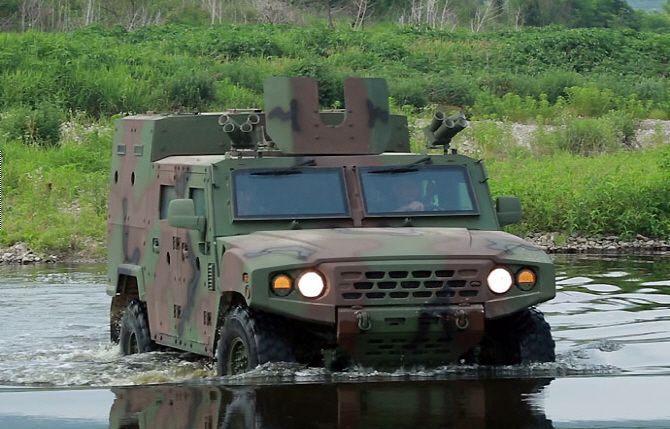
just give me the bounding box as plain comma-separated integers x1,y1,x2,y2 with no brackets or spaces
107,77,555,374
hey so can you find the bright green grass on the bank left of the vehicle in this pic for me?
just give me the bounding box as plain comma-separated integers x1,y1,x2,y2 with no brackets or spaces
0,118,111,256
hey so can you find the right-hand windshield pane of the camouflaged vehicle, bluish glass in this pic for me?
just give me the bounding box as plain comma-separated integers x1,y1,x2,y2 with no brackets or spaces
360,165,479,216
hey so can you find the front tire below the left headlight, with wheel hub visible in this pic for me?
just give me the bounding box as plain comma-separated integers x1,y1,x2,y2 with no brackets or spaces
216,307,295,375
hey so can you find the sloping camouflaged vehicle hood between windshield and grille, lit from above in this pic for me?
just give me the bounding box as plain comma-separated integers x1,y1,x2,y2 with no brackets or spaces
220,228,551,266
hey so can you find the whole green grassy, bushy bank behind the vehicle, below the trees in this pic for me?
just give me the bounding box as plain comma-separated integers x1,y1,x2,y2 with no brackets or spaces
0,24,670,254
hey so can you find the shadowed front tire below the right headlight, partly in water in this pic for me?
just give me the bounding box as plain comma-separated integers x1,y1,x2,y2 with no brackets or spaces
478,308,556,365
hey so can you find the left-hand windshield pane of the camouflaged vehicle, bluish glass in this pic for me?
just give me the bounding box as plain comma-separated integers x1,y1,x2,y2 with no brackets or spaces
233,168,349,218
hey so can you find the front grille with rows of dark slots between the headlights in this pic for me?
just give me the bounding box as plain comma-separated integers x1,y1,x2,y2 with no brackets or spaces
337,267,483,305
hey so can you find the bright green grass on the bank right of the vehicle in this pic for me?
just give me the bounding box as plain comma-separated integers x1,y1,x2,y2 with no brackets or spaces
487,146,670,237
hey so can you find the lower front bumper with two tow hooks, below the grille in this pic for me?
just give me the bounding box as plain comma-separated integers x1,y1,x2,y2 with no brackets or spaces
337,305,484,366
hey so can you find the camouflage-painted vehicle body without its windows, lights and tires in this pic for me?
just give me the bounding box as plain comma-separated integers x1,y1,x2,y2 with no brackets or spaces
107,78,555,364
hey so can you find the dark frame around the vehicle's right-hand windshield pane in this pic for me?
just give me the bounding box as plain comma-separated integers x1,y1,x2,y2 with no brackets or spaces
357,164,481,218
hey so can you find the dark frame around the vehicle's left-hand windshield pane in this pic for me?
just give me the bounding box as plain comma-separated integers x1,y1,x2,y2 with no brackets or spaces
230,166,351,220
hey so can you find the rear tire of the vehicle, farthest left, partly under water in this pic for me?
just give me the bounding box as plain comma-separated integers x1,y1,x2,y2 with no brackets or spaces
119,299,156,355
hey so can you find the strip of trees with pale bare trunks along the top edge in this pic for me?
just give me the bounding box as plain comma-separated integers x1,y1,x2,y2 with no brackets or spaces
0,0,670,32
